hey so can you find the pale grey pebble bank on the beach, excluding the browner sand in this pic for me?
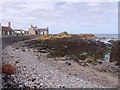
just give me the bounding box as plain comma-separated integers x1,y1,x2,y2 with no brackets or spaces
3,46,109,88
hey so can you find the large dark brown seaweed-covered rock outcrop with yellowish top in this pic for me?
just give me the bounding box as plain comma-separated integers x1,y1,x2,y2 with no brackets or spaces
24,34,107,59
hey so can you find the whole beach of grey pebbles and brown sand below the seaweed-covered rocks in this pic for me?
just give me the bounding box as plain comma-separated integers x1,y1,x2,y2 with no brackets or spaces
2,34,118,90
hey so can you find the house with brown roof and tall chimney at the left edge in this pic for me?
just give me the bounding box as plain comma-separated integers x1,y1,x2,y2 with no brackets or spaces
0,22,14,36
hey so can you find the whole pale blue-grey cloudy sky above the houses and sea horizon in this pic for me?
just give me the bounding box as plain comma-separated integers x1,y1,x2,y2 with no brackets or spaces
0,0,118,34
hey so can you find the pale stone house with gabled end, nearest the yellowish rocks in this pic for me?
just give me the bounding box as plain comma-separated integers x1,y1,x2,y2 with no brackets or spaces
28,25,49,35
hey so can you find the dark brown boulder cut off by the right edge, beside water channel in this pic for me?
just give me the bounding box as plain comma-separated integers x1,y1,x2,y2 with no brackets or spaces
110,41,120,65
